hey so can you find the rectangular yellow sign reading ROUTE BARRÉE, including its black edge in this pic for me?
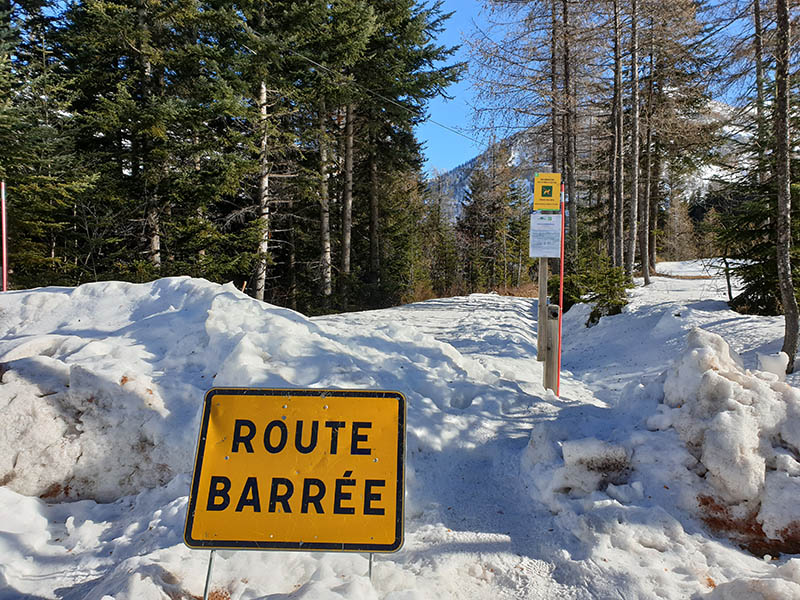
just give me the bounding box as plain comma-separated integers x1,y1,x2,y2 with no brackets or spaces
184,388,406,552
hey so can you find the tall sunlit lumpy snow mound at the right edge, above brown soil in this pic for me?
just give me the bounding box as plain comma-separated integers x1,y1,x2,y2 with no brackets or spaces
648,329,800,550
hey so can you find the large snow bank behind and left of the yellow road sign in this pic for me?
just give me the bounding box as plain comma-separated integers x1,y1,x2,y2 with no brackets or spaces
0,277,518,502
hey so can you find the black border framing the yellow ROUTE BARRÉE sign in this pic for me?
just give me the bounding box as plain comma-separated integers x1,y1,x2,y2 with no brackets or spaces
183,387,406,552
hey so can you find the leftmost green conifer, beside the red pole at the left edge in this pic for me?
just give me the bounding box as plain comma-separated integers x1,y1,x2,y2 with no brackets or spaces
6,2,93,287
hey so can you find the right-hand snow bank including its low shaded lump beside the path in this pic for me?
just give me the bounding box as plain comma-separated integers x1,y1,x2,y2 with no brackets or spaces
523,328,800,553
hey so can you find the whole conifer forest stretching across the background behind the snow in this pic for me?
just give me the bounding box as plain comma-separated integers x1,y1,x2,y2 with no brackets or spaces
0,0,800,328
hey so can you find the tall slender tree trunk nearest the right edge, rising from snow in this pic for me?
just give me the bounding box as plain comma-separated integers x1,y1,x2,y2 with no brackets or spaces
775,0,798,373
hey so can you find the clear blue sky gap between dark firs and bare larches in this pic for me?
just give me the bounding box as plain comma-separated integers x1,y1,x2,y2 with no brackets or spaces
416,0,485,172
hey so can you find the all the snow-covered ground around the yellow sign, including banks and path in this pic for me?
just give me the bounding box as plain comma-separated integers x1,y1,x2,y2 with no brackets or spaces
0,263,800,600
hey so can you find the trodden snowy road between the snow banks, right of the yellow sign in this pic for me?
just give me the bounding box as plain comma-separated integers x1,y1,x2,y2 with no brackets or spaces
315,294,591,599
